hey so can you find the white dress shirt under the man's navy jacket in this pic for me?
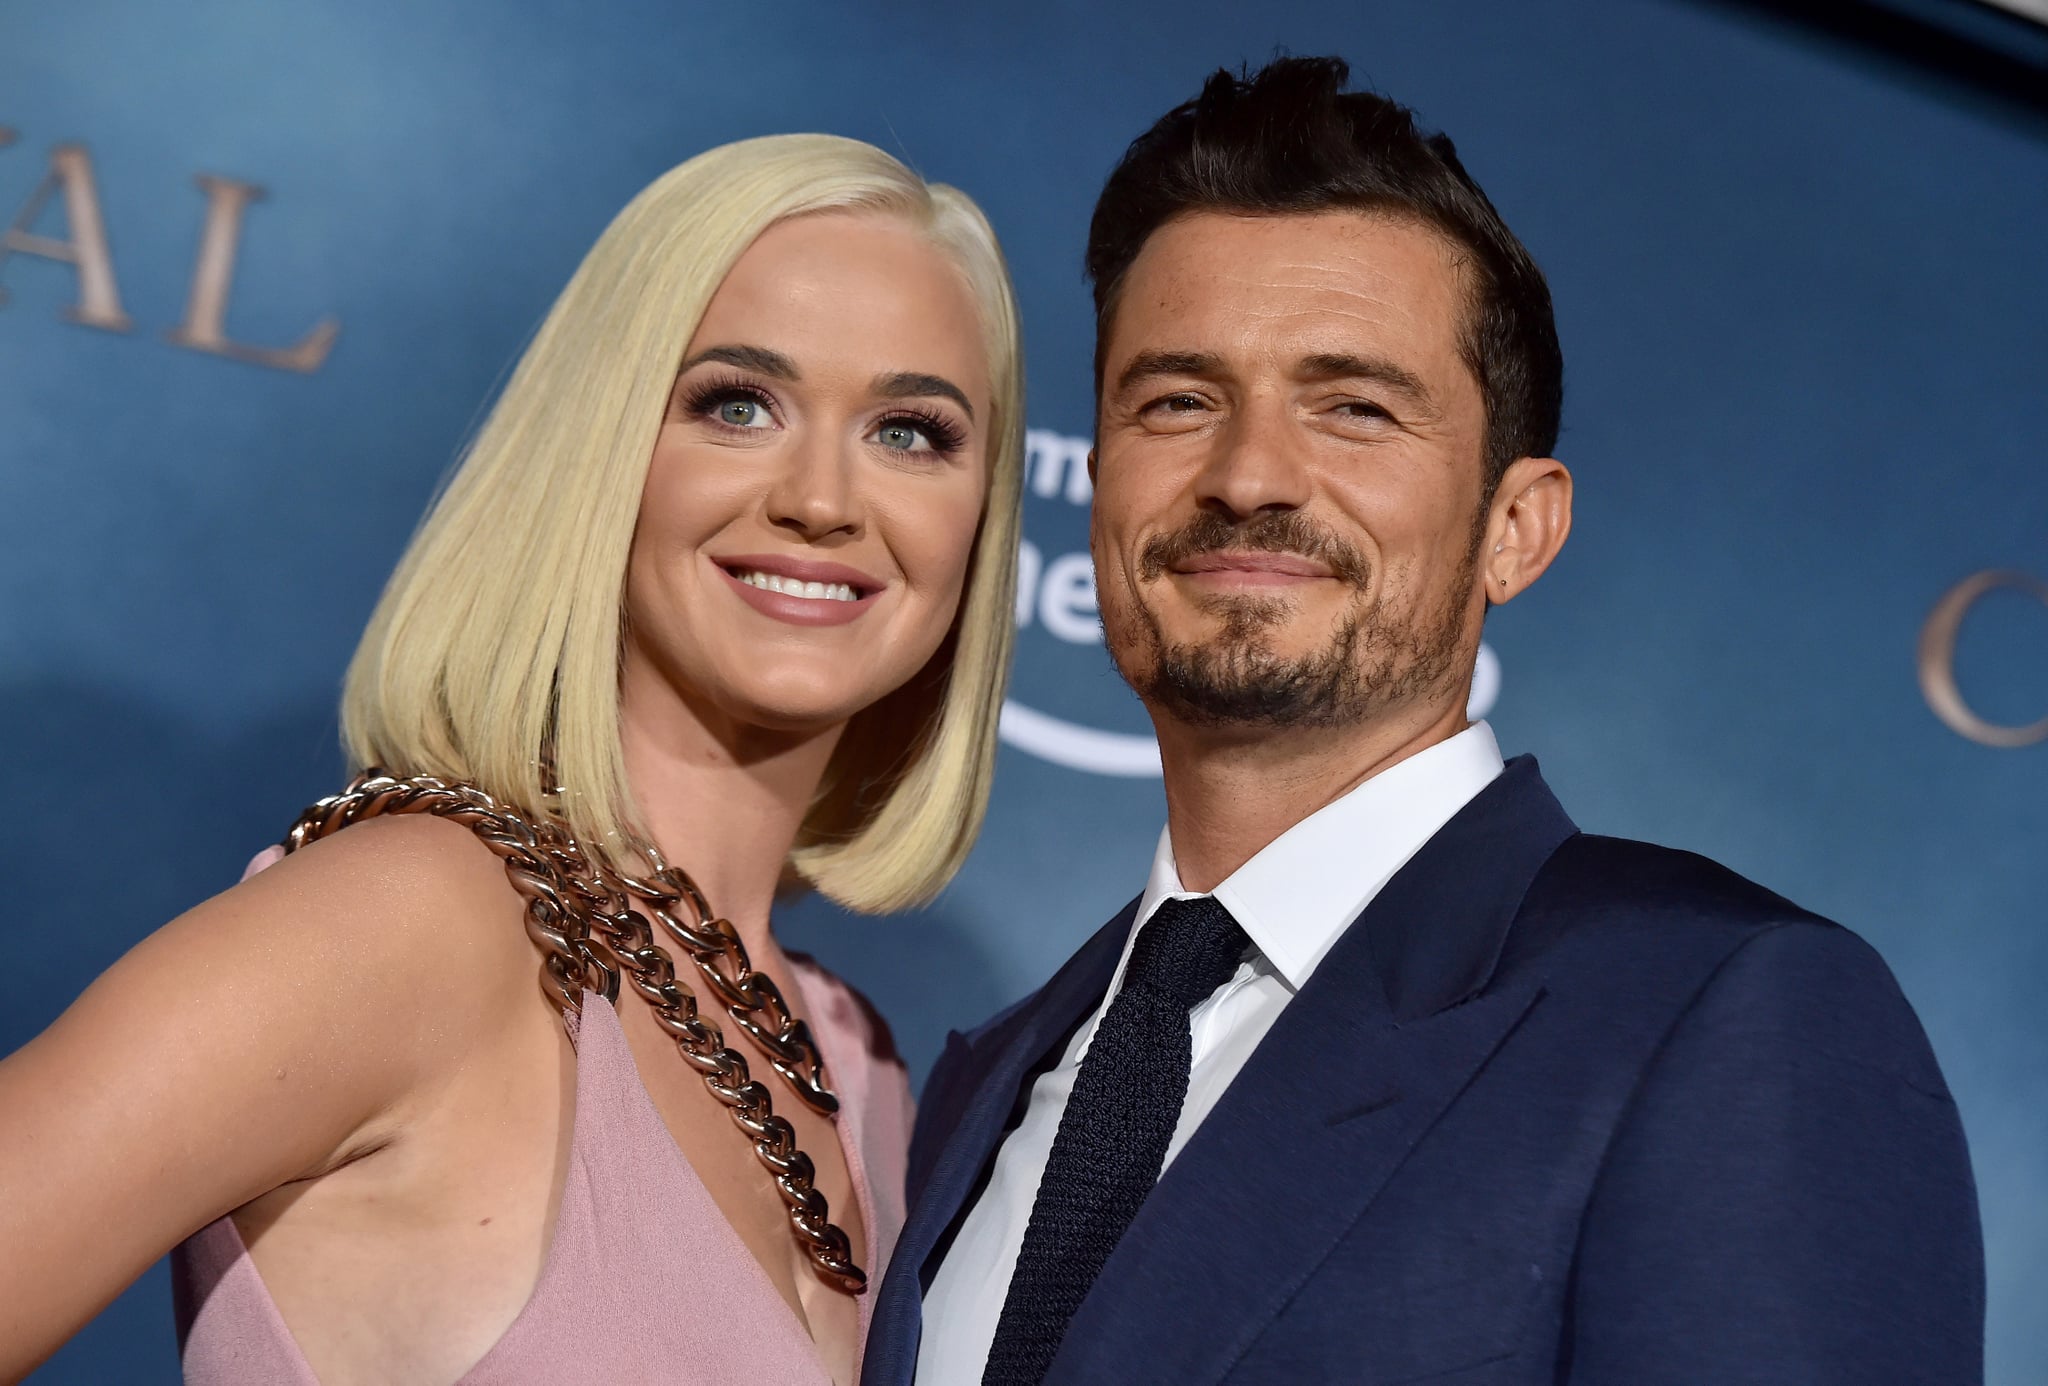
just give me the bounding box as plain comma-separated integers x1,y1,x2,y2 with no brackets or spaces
918,723,1501,1386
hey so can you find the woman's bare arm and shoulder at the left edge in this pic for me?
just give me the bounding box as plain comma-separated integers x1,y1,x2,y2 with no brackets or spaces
0,819,539,1382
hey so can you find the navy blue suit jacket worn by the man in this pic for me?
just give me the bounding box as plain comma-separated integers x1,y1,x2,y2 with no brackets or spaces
862,757,1985,1386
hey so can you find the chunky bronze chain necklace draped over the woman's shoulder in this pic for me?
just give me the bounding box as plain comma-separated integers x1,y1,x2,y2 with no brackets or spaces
285,770,868,1294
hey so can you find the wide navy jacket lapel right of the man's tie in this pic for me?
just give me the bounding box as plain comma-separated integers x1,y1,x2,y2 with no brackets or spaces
1047,757,1575,1382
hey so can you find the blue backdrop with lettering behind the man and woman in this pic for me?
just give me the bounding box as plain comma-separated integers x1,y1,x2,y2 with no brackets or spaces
0,0,2048,1386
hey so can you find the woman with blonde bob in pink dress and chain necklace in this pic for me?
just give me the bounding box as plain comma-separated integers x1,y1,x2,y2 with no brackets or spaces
0,135,1022,1386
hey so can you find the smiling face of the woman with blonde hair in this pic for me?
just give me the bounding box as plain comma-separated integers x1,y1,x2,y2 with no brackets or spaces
625,213,991,731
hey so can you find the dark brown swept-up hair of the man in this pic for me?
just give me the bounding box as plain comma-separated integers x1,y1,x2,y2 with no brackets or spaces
1087,57,1565,495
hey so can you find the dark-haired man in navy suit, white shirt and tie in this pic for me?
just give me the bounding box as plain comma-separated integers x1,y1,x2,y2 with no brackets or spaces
864,59,1982,1386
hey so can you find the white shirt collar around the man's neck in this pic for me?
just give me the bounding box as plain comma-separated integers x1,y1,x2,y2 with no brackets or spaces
1138,723,1501,993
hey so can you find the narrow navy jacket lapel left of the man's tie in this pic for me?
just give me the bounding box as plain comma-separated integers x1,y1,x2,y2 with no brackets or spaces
862,901,1137,1384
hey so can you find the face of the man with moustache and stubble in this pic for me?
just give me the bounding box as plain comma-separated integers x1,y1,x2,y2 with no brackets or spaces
1090,211,1485,729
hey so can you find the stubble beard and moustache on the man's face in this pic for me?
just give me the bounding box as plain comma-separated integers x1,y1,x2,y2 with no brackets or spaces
1108,514,1485,731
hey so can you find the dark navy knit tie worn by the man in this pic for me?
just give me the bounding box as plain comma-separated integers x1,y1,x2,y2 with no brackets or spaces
981,895,1251,1386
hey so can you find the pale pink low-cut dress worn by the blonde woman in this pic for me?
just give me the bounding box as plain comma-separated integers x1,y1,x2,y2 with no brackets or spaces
172,843,911,1386
